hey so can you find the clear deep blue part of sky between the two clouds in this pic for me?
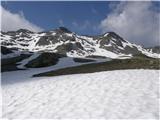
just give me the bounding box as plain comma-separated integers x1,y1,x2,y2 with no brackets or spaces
2,1,117,34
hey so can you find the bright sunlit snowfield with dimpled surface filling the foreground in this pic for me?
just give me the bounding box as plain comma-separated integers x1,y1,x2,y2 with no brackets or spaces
2,70,160,119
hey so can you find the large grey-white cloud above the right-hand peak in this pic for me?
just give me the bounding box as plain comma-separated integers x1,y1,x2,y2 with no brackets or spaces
100,1,160,46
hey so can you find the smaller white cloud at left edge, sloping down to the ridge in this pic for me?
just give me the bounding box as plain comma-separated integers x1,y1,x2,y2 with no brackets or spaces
0,6,43,32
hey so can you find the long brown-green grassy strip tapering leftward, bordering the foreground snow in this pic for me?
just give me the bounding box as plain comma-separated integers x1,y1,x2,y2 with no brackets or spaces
34,55,160,77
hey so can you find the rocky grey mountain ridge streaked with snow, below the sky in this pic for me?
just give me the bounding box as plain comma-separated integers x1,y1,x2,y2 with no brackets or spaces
1,27,160,58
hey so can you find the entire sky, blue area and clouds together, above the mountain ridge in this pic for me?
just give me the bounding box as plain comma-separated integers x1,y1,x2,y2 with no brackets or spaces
1,1,160,46
